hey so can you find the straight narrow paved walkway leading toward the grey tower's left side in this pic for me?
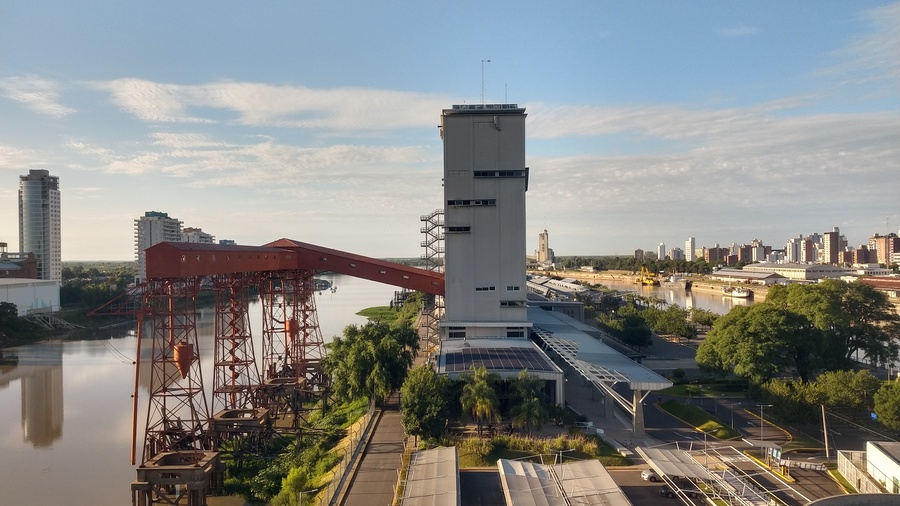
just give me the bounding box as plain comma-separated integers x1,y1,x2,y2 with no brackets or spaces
341,393,405,506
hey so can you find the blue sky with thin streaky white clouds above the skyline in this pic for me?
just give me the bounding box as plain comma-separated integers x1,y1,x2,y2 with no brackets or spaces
0,0,900,261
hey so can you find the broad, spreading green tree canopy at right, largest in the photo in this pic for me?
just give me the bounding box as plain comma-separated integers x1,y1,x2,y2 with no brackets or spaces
697,280,900,383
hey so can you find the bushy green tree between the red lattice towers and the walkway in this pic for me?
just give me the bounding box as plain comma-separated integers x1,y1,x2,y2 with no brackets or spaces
324,322,419,402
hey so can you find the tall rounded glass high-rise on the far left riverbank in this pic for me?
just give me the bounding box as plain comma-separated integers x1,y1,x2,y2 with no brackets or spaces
19,169,62,281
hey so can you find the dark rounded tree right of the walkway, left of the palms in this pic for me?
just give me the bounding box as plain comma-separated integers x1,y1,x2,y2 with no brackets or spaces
400,365,450,438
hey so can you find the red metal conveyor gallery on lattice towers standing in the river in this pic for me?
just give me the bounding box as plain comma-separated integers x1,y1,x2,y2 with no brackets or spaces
91,239,444,506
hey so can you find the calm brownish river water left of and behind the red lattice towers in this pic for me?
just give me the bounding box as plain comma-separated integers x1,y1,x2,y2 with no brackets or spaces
0,275,397,506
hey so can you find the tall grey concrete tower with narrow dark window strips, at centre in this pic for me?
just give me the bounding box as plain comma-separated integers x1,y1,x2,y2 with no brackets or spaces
441,104,531,339
